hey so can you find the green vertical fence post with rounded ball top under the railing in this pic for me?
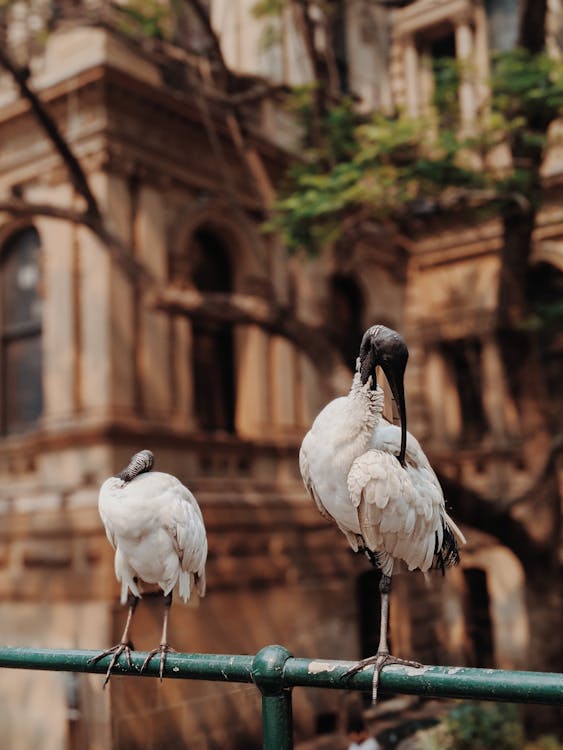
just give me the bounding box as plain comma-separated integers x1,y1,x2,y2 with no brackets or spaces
252,646,293,750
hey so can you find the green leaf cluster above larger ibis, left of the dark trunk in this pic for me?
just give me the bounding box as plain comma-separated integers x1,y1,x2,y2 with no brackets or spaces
267,90,486,252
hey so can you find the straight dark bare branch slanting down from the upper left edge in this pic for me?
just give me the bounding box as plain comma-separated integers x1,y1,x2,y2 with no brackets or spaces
0,45,100,218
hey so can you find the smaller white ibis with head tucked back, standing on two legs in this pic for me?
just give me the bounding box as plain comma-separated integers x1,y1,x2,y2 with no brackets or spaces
91,450,207,687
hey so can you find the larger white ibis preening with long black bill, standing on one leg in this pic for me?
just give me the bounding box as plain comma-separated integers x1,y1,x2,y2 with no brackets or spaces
299,325,465,703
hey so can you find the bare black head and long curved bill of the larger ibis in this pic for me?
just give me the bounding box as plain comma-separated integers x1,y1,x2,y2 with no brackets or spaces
359,325,409,466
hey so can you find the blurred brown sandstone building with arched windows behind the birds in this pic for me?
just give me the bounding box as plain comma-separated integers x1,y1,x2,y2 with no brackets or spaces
0,0,563,749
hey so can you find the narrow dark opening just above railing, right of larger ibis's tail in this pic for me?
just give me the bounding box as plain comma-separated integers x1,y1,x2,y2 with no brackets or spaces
463,568,495,669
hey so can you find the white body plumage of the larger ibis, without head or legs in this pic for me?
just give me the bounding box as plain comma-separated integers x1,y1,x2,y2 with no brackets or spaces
299,372,461,576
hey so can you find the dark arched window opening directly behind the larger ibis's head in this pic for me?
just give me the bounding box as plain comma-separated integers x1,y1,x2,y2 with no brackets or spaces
328,275,364,372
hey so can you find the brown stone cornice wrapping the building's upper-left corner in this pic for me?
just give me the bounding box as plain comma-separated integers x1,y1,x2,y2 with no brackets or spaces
0,65,286,211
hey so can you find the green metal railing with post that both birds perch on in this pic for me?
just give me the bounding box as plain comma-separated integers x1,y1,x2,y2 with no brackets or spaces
0,646,563,750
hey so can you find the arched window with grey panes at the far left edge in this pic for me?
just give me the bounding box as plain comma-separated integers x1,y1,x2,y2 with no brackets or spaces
0,227,43,435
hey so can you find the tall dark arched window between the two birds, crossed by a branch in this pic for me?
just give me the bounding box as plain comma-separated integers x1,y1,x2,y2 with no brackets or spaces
189,226,235,432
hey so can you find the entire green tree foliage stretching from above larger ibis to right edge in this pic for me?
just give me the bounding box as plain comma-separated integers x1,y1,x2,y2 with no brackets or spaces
269,49,563,251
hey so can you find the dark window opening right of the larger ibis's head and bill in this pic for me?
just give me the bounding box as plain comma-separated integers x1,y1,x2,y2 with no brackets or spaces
441,339,487,443
